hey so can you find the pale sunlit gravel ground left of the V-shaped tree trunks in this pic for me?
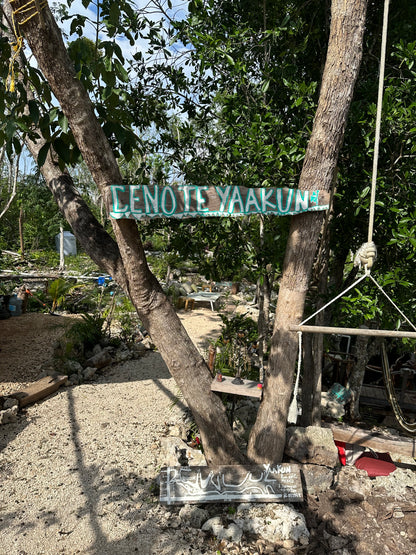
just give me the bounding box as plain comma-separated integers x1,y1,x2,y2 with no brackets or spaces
0,310,221,555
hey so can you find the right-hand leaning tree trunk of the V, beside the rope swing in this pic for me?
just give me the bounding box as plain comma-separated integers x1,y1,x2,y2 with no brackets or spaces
248,0,367,462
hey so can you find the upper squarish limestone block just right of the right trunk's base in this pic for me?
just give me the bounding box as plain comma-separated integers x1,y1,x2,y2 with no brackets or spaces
285,426,338,467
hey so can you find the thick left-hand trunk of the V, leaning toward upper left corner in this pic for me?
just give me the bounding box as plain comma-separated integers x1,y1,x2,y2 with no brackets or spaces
5,0,244,470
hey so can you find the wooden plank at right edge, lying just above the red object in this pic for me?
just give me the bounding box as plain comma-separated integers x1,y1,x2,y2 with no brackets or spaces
324,424,416,458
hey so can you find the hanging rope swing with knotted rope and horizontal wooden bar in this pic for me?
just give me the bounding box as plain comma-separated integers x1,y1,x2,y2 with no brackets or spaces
288,0,416,434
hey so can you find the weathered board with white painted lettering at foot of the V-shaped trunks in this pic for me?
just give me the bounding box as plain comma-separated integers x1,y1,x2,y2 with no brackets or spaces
160,464,303,505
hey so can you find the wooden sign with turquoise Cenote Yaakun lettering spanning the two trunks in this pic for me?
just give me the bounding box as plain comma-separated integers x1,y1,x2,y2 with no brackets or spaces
107,185,329,220
